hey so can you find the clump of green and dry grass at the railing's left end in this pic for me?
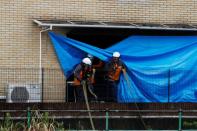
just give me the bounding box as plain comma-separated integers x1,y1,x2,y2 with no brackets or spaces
0,110,65,131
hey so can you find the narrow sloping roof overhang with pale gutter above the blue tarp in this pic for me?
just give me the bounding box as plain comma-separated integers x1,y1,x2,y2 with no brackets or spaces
33,20,197,31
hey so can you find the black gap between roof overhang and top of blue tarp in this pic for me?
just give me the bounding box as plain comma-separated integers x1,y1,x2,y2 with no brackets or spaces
67,28,197,49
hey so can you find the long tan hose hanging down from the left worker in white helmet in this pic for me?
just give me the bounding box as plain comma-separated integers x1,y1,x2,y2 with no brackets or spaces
82,82,95,130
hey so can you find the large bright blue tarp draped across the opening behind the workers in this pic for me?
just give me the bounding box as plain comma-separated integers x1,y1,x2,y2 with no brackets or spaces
49,32,197,103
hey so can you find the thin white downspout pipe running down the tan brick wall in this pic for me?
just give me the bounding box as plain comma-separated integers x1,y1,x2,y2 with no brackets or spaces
39,26,52,88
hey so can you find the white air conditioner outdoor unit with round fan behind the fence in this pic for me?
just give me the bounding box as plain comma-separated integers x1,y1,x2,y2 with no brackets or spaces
6,84,42,103
